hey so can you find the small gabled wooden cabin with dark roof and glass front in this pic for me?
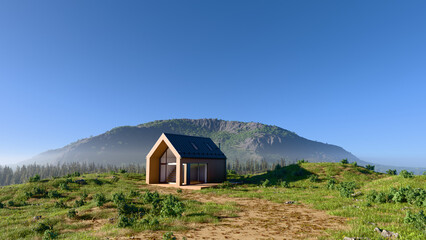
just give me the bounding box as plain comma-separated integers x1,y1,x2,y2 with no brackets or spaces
146,133,226,186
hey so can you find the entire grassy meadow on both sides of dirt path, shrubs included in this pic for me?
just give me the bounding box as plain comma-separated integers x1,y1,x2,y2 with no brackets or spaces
0,163,426,240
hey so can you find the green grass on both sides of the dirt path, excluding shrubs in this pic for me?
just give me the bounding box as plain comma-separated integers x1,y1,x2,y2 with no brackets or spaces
0,163,426,240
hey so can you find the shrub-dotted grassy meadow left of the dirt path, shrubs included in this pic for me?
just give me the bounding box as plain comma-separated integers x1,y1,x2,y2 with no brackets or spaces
0,173,238,240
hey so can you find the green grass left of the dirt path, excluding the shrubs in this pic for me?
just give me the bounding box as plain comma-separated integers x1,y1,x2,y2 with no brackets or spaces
0,173,238,240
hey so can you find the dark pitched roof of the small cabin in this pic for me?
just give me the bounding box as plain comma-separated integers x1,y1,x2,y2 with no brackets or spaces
164,133,226,159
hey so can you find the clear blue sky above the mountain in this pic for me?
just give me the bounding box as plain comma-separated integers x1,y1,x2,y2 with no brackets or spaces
0,0,426,167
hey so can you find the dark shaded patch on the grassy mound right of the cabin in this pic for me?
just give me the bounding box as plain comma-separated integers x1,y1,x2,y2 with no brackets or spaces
241,164,315,185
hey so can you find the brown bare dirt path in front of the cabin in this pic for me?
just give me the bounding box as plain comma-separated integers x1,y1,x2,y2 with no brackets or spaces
119,186,346,239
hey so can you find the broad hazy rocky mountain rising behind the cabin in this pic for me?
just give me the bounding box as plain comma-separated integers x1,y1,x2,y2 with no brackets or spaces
25,119,365,165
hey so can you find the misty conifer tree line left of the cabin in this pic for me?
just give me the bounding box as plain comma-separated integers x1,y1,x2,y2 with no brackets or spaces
0,163,145,186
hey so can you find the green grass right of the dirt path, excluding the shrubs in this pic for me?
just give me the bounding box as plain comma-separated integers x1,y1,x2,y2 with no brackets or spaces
202,163,426,239
